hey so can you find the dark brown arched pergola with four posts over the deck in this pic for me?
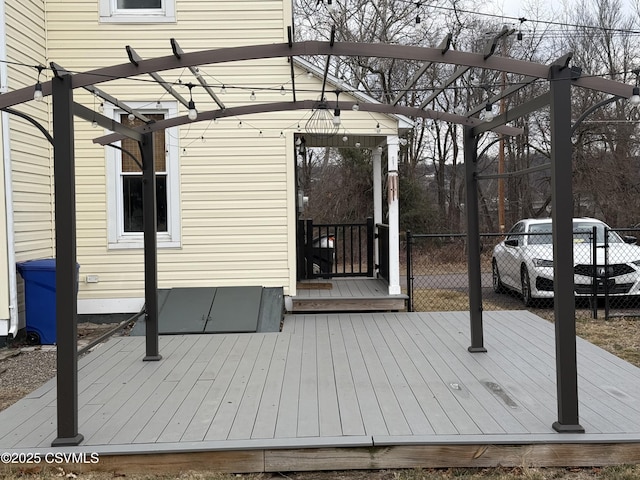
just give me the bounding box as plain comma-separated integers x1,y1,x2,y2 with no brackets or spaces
0,30,632,446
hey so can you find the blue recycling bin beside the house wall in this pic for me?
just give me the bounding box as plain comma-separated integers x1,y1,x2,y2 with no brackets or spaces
16,258,79,345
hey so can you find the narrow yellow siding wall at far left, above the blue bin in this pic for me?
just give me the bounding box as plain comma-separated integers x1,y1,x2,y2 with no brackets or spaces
0,0,54,335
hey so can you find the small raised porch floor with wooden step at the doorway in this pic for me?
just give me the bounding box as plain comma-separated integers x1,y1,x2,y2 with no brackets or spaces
292,277,409,312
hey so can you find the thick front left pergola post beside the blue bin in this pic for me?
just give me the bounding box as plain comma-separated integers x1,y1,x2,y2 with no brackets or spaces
51,74,84,447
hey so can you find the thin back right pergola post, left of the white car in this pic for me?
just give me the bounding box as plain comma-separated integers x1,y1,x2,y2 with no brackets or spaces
464,127,487,353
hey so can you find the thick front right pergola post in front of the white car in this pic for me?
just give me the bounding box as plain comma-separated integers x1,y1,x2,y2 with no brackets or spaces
549,65,584,433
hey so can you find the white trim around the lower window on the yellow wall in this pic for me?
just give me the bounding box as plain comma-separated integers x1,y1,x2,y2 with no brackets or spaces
104,101,182,249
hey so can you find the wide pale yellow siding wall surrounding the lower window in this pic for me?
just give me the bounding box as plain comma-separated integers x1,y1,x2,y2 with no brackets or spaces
38,0,396,313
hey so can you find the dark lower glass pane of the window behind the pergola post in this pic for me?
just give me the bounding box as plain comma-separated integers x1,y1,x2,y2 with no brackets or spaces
122,175,167,233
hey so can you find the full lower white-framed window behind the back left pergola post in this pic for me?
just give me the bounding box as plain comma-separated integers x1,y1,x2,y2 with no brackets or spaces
105,102,180,248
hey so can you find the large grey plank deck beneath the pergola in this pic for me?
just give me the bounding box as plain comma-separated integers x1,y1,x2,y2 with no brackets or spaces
0,311,640,473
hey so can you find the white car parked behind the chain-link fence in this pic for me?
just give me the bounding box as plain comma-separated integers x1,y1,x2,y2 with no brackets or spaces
491,218,640,306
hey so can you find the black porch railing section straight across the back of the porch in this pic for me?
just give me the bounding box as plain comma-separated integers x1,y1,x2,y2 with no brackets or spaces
299,218,374,278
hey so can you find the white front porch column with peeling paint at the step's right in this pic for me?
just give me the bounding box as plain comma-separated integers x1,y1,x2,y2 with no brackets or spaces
387,135,401,295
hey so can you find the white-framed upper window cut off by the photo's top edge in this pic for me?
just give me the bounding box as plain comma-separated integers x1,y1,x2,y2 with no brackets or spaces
100,0,176,23
